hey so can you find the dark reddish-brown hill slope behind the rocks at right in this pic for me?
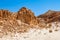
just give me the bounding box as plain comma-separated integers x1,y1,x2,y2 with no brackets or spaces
38,10,60,22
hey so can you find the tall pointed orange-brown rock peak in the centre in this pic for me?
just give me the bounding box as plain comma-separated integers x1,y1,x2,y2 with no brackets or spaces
17,7,38,25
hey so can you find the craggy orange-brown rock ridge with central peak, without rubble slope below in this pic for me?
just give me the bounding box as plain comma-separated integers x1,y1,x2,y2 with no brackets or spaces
0,7,38,25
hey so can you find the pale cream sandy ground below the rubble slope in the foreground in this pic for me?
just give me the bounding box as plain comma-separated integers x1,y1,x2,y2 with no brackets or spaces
0,28,60,40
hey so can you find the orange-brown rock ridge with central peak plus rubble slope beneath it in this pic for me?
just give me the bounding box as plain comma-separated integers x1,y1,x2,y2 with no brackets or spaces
0,7,38,35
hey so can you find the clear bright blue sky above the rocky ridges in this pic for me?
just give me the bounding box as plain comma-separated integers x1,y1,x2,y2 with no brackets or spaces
0,0,60,16
